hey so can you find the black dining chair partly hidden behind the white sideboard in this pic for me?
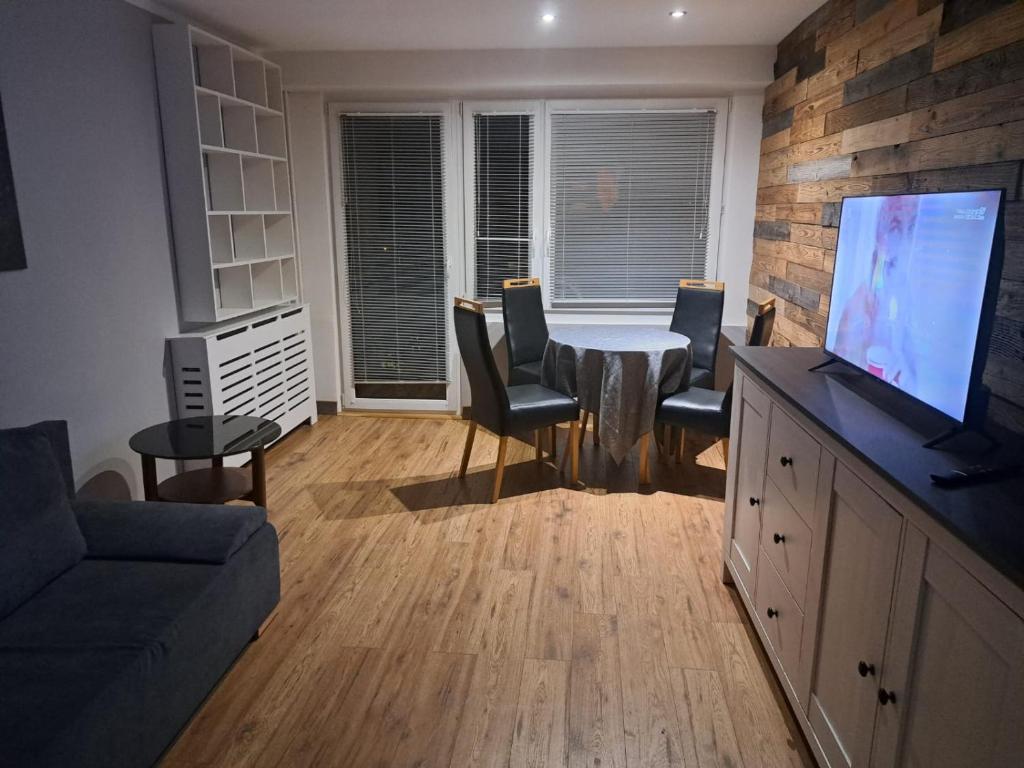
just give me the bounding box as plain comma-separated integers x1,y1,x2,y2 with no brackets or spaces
654,299,775,466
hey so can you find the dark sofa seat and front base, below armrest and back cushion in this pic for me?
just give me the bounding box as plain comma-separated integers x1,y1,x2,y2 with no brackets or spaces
0,524,281,768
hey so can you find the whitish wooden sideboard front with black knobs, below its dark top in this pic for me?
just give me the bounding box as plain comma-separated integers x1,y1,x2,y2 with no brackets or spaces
723,367,1024,768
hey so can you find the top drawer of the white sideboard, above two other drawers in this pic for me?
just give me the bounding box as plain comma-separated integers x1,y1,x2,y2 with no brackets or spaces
768,406,821,522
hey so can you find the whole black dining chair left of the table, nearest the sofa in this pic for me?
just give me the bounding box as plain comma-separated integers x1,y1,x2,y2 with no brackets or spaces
455,298,580,502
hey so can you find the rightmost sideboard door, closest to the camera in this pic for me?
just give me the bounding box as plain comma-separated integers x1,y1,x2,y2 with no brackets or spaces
872,527,1024,768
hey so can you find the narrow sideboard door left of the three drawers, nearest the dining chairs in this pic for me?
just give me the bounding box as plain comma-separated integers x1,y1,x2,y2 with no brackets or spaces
727,376,771,599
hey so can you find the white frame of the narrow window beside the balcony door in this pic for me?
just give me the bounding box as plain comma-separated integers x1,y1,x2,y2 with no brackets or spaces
462,99,547,308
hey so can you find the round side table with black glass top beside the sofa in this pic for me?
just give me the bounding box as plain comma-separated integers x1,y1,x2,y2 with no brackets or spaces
128,416,281,507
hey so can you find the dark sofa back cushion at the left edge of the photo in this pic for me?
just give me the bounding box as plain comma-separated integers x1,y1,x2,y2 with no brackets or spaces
0,429,85,618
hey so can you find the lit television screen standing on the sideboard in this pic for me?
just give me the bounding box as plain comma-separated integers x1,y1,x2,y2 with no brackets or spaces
825,190,1002,422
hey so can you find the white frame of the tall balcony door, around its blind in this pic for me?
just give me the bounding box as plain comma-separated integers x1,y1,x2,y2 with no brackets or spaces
327,101,465,413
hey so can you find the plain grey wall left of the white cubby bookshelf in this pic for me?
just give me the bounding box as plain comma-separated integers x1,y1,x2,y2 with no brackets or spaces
0,0,178,496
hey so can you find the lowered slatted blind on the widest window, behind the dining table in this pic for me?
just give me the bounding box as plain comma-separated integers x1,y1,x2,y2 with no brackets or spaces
549,111,716,302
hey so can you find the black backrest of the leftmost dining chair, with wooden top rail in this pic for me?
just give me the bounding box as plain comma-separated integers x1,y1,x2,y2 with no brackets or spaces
455,297,509,434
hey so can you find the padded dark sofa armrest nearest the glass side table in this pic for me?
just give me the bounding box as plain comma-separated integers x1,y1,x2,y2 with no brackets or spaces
72,501,266,563
